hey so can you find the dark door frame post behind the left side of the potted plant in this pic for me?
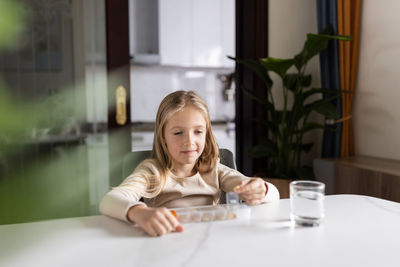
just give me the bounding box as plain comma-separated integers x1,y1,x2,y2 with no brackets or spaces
235,0,268,176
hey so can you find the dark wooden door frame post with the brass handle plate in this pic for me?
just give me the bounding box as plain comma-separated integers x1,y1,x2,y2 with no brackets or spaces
105,0,132,186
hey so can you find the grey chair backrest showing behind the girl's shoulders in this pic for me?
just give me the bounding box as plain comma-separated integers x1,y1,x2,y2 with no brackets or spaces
122,148,236,180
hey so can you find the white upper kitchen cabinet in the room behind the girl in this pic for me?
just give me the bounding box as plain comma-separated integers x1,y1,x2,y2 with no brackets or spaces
158,0,235,67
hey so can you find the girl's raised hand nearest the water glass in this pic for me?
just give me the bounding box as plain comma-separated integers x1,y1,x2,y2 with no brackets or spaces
233,178,268,205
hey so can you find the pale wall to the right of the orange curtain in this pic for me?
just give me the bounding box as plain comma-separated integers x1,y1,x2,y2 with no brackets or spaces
353,0,400,160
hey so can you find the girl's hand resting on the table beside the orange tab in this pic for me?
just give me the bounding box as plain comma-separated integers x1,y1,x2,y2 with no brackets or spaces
127,205,183,236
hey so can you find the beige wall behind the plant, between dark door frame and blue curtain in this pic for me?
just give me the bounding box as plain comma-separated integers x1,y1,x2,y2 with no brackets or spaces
268,0,323,165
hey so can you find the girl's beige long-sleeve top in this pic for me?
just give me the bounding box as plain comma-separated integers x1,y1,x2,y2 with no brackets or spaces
100,161,279,221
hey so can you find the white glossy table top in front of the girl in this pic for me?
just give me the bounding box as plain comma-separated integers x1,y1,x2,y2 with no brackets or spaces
0,195,400,267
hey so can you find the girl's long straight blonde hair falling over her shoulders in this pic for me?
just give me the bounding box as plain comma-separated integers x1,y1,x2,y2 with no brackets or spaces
130,91,219,198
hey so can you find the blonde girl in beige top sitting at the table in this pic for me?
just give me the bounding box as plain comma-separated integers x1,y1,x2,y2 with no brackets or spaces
100,91,279,236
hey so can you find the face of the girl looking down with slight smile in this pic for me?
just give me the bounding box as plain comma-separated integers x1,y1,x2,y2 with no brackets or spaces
164,106,207,172
